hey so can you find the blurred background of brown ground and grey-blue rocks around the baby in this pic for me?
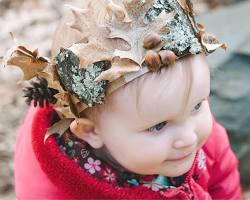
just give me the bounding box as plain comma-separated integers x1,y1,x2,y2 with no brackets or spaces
0,0,250,200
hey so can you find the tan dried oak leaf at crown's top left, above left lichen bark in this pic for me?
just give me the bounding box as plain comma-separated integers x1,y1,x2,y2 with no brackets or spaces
66,3,113,68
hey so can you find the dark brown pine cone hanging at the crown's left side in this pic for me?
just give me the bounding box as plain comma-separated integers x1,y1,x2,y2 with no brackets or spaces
23,77,58,108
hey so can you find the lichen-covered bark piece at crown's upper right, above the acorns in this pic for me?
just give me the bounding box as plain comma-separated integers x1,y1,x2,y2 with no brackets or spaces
144,0,202,57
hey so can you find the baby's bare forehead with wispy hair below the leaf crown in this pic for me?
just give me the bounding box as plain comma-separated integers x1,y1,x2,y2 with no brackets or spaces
109,55,209,126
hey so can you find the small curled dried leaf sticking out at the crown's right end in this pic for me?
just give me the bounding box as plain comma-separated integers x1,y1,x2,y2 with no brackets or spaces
201,33,227,53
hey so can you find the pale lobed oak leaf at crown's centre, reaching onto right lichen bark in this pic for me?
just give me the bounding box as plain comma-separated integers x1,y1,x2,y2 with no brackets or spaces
109,10,174,66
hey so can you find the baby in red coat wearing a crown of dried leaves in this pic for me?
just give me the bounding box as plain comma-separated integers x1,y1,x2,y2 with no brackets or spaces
6,0,241,200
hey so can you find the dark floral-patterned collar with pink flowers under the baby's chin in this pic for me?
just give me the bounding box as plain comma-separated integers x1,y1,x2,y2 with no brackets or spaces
57,131,185,191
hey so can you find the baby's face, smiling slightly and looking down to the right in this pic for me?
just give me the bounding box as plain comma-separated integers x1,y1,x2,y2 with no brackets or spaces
95,55,212,177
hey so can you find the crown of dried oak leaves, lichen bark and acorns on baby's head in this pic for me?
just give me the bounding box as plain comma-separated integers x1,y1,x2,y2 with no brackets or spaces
1,0,226,134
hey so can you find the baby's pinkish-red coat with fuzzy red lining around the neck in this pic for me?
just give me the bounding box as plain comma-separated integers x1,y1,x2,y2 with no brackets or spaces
15,108,241,200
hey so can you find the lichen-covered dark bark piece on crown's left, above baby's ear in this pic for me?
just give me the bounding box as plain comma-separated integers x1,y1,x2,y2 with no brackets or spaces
56,48,110,107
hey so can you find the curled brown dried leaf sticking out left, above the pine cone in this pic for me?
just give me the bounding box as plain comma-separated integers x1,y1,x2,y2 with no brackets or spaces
3,46,49,80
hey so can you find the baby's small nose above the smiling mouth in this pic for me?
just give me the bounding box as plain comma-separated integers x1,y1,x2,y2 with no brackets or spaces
173,132,198,149
